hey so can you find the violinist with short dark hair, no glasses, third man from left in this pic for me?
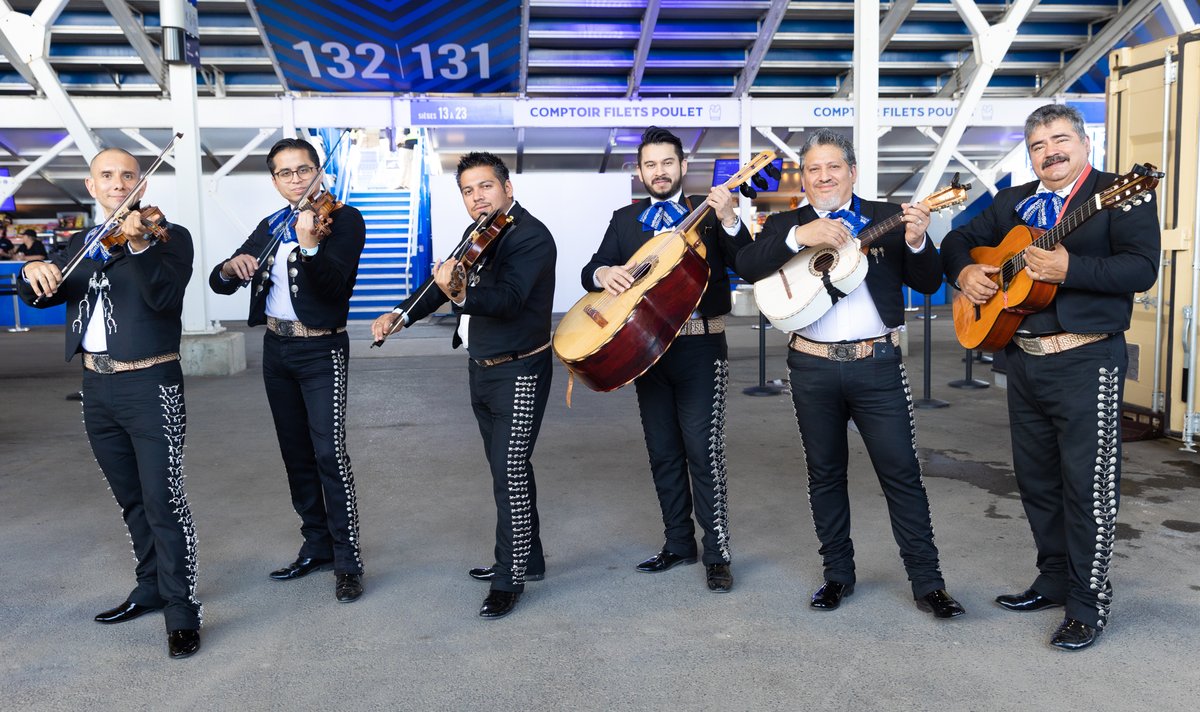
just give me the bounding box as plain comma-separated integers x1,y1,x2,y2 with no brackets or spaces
371,152,558,620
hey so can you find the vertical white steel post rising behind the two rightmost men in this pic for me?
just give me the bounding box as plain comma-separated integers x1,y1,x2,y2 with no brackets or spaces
854,0,880,201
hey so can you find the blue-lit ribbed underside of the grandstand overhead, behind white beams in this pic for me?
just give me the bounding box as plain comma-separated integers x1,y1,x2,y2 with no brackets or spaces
0,0,1200,212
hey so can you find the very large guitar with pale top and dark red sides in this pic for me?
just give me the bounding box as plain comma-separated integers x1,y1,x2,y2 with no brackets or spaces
553,151,778,391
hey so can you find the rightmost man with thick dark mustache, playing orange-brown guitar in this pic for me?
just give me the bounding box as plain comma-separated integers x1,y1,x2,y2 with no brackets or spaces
942,104,1159,651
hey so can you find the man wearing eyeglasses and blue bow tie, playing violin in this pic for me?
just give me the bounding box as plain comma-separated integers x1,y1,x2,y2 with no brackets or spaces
209,138,366,603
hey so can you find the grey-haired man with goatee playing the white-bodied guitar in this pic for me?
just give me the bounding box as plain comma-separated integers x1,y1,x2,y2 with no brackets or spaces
738,128,966,618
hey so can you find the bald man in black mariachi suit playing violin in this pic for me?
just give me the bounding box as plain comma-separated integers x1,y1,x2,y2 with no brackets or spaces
18,149,200,658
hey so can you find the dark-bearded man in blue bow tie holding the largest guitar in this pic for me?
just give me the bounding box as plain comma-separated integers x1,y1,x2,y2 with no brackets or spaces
582,126,750,593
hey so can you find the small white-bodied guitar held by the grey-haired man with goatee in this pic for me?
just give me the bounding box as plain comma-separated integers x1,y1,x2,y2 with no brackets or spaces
754,174,971,331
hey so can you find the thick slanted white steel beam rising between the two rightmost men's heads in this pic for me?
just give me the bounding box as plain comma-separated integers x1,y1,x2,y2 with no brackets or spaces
912,0,1037,201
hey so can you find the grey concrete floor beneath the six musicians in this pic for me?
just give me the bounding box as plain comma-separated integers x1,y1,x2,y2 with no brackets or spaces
0,312,1200,710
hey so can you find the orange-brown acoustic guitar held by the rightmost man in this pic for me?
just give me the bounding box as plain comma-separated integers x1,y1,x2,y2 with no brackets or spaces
954,163,1163,351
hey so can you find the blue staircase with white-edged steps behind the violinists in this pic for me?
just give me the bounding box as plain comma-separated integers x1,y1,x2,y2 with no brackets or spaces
347,191,418,319
